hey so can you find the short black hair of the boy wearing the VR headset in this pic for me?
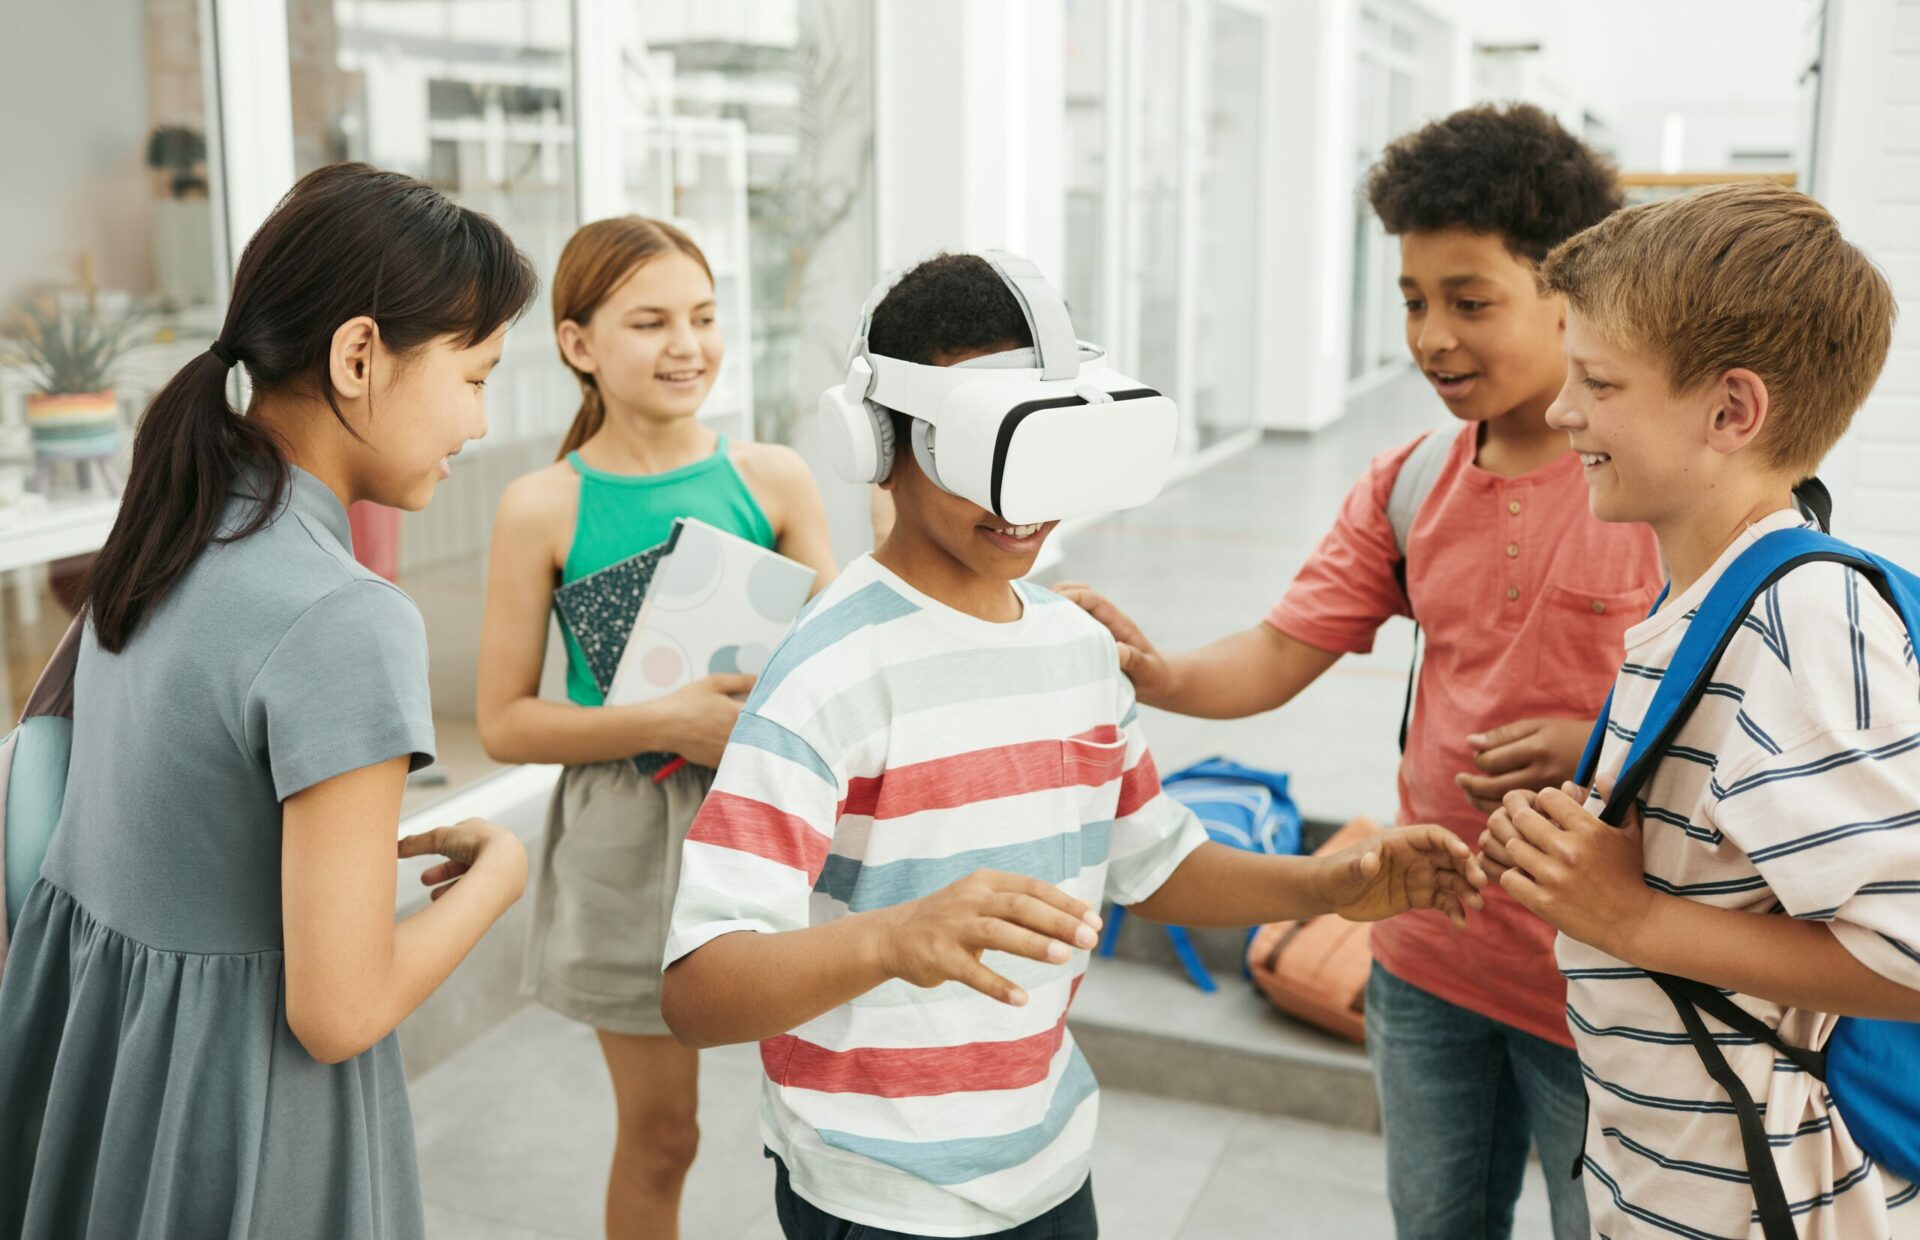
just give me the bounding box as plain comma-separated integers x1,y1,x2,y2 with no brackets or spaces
866,253,1033,367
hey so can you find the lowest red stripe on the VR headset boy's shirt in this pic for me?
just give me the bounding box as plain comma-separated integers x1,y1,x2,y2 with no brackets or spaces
760,977,1081,1098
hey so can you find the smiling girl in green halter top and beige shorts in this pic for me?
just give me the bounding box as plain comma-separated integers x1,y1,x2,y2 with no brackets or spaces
476,217,833,1238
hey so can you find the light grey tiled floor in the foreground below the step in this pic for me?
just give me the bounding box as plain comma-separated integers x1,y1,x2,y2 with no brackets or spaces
413,1005,1548,1240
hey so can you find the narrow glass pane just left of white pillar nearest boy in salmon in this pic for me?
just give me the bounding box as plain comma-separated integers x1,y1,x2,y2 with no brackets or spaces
1194,4,1267,447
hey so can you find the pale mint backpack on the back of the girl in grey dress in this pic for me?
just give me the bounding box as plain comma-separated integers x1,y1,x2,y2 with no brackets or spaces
0,618,84,969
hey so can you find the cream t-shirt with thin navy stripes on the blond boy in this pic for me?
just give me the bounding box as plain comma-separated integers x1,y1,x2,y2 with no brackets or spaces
1557,513,1920,1240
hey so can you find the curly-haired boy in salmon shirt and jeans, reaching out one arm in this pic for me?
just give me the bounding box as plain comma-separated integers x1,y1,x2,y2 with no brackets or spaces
1060,106,1661,1240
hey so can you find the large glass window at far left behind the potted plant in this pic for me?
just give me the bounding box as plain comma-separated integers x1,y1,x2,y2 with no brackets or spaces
0,0,227,718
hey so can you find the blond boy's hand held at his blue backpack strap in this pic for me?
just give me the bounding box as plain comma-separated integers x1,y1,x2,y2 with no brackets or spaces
1488,783,1653,960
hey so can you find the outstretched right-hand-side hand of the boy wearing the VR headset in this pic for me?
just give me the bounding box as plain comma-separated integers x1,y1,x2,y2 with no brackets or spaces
1319,825,1486,925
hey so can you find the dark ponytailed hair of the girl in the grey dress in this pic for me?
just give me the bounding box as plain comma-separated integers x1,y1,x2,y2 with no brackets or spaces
86,163,540,653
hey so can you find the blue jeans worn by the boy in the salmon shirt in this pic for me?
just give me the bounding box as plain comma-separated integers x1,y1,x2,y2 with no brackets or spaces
1367,966,1592,1240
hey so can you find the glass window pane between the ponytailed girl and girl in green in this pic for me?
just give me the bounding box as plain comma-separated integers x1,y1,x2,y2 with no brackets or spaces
288,0,580,812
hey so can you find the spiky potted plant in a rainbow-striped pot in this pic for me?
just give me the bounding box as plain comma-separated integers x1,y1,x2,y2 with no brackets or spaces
6,290,146,493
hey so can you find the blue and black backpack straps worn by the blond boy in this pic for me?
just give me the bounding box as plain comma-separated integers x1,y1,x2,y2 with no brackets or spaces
1580,530,1920,1240
